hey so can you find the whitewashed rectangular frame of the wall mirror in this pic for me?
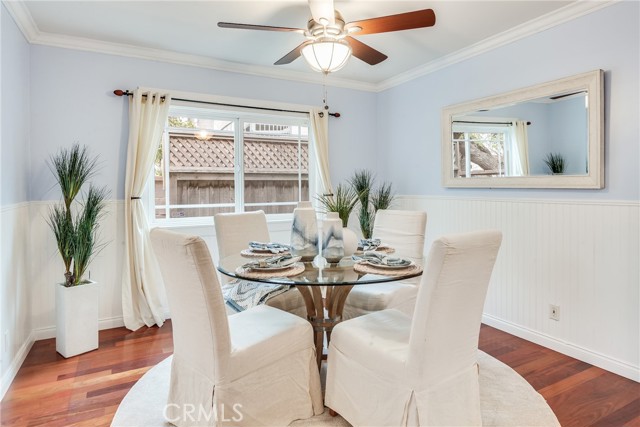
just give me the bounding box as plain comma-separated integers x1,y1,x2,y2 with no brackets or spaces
442,70,604,189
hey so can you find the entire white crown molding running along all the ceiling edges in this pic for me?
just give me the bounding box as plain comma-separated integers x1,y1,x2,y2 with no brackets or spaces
3,0,623,92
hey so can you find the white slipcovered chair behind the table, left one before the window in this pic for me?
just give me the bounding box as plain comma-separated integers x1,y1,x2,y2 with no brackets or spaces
213,211,307,319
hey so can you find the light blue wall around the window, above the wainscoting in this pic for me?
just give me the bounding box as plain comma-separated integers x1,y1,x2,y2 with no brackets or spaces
31,45,377,200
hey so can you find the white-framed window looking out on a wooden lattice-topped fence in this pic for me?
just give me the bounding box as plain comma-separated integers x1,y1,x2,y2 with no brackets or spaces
153,106,310,220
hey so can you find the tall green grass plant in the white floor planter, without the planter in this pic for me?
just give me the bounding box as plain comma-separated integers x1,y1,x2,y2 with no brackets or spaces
47,144,109,287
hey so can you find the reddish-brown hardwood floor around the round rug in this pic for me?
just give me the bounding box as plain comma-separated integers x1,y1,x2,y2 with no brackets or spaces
0,321,640,427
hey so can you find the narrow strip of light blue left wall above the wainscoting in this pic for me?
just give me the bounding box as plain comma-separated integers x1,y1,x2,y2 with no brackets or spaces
0,5,30,206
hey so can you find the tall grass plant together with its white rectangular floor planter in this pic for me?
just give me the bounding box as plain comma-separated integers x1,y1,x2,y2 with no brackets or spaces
48,144,109,357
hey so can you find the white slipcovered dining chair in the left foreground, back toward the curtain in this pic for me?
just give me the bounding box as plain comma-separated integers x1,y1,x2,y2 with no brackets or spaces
151,229,323,426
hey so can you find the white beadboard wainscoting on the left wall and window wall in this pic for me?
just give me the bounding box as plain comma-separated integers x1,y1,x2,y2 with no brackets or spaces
0,200,291,398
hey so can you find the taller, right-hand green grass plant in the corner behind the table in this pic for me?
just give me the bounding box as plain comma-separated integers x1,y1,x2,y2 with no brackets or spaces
349,170,395,239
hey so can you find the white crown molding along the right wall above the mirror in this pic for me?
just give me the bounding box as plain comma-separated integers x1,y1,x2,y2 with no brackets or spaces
376,0,622,92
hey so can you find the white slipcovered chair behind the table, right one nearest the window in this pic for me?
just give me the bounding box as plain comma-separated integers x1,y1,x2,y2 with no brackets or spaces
342,210,427,319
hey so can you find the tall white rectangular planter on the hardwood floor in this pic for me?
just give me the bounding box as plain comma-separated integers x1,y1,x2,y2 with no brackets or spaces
56,282,99,357
